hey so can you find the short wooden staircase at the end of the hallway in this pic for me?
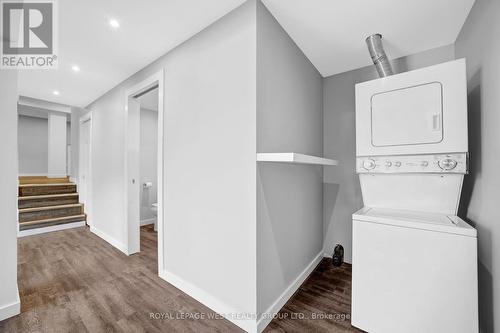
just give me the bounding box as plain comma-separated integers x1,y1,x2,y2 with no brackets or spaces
18,177,87,232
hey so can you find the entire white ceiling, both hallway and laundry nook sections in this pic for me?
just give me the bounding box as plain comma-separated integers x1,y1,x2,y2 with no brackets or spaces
19,0,474,107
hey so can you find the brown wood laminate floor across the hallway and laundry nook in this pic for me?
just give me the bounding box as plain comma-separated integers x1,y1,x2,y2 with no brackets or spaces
0,226,362,333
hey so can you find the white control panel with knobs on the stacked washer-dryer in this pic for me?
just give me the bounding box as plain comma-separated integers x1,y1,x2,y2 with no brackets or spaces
356,153,468,174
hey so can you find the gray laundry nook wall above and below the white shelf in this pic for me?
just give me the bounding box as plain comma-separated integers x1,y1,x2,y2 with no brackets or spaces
257,0,323,313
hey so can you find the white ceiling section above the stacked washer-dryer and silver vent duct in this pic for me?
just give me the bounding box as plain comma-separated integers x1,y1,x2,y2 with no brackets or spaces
263,0,474,76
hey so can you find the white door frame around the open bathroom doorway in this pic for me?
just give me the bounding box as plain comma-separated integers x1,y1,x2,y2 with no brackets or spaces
124,69,165,273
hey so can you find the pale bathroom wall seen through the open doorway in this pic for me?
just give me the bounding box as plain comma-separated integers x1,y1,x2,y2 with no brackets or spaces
139,108,158,224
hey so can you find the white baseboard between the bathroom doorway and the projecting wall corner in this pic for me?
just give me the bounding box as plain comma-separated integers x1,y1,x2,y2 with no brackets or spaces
159,271,257,333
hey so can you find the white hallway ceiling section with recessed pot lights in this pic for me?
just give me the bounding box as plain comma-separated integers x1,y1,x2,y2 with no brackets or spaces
19,0,245,107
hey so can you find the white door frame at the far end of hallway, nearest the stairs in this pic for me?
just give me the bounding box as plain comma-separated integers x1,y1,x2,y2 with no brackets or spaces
78,111,94,226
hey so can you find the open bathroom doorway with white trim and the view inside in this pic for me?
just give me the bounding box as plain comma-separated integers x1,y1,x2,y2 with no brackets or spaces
124,71,164,272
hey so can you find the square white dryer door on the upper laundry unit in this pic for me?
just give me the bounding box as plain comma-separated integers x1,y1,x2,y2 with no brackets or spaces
371,82,443,147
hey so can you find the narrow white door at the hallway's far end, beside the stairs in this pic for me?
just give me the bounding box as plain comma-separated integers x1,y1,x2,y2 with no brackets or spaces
78,118,91,224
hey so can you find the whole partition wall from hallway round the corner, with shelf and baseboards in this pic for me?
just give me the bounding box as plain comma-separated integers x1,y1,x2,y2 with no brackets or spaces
88,0,326,332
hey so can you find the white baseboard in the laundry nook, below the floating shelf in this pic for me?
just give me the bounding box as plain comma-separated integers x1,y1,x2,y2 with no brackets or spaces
257,251,324,333
